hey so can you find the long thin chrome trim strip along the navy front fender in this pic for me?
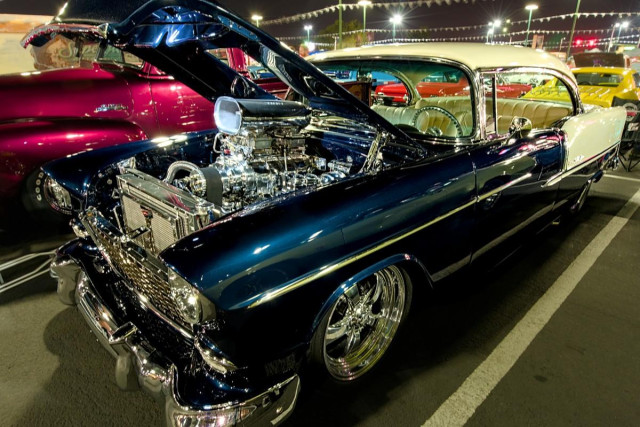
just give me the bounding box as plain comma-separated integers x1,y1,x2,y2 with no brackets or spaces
249,196,478,308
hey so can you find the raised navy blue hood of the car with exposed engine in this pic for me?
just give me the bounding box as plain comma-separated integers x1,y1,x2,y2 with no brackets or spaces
23,0,404,137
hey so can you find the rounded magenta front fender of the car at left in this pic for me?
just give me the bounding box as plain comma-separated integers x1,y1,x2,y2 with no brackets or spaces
0,119,146,201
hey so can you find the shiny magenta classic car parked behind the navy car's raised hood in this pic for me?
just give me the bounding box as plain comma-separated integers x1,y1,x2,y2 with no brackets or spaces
0,28,258,219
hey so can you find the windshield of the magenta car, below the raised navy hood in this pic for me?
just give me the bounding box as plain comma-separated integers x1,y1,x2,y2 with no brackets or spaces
31,34,143,70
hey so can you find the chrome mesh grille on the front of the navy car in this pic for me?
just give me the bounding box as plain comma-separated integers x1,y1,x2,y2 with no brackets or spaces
90,216,191,330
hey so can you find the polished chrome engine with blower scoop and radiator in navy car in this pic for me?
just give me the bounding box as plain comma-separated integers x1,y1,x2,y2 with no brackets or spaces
118,97,352,254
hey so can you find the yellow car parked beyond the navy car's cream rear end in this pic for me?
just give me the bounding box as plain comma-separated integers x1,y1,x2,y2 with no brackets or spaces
523,67,640,111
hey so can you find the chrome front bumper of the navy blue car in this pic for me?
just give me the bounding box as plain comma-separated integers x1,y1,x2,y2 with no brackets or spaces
51,255,300,427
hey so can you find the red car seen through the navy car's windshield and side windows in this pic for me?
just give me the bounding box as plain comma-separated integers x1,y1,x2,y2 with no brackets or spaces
376,71,531,103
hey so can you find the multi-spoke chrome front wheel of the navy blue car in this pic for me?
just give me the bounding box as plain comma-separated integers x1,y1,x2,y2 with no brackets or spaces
322,266,409,381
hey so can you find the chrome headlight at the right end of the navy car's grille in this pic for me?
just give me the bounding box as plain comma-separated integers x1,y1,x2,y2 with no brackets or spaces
167,269,216,325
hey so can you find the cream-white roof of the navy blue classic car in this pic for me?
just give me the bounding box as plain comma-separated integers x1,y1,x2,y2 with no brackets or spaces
306,43,572,78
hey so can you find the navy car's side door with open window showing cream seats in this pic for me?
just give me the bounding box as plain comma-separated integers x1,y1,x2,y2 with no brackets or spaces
471,71,573,259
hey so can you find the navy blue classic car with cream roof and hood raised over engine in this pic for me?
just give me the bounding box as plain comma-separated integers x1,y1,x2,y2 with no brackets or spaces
42,0,625,426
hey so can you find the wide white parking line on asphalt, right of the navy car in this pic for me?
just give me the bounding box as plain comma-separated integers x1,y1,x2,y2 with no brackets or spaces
423,190,640,426
